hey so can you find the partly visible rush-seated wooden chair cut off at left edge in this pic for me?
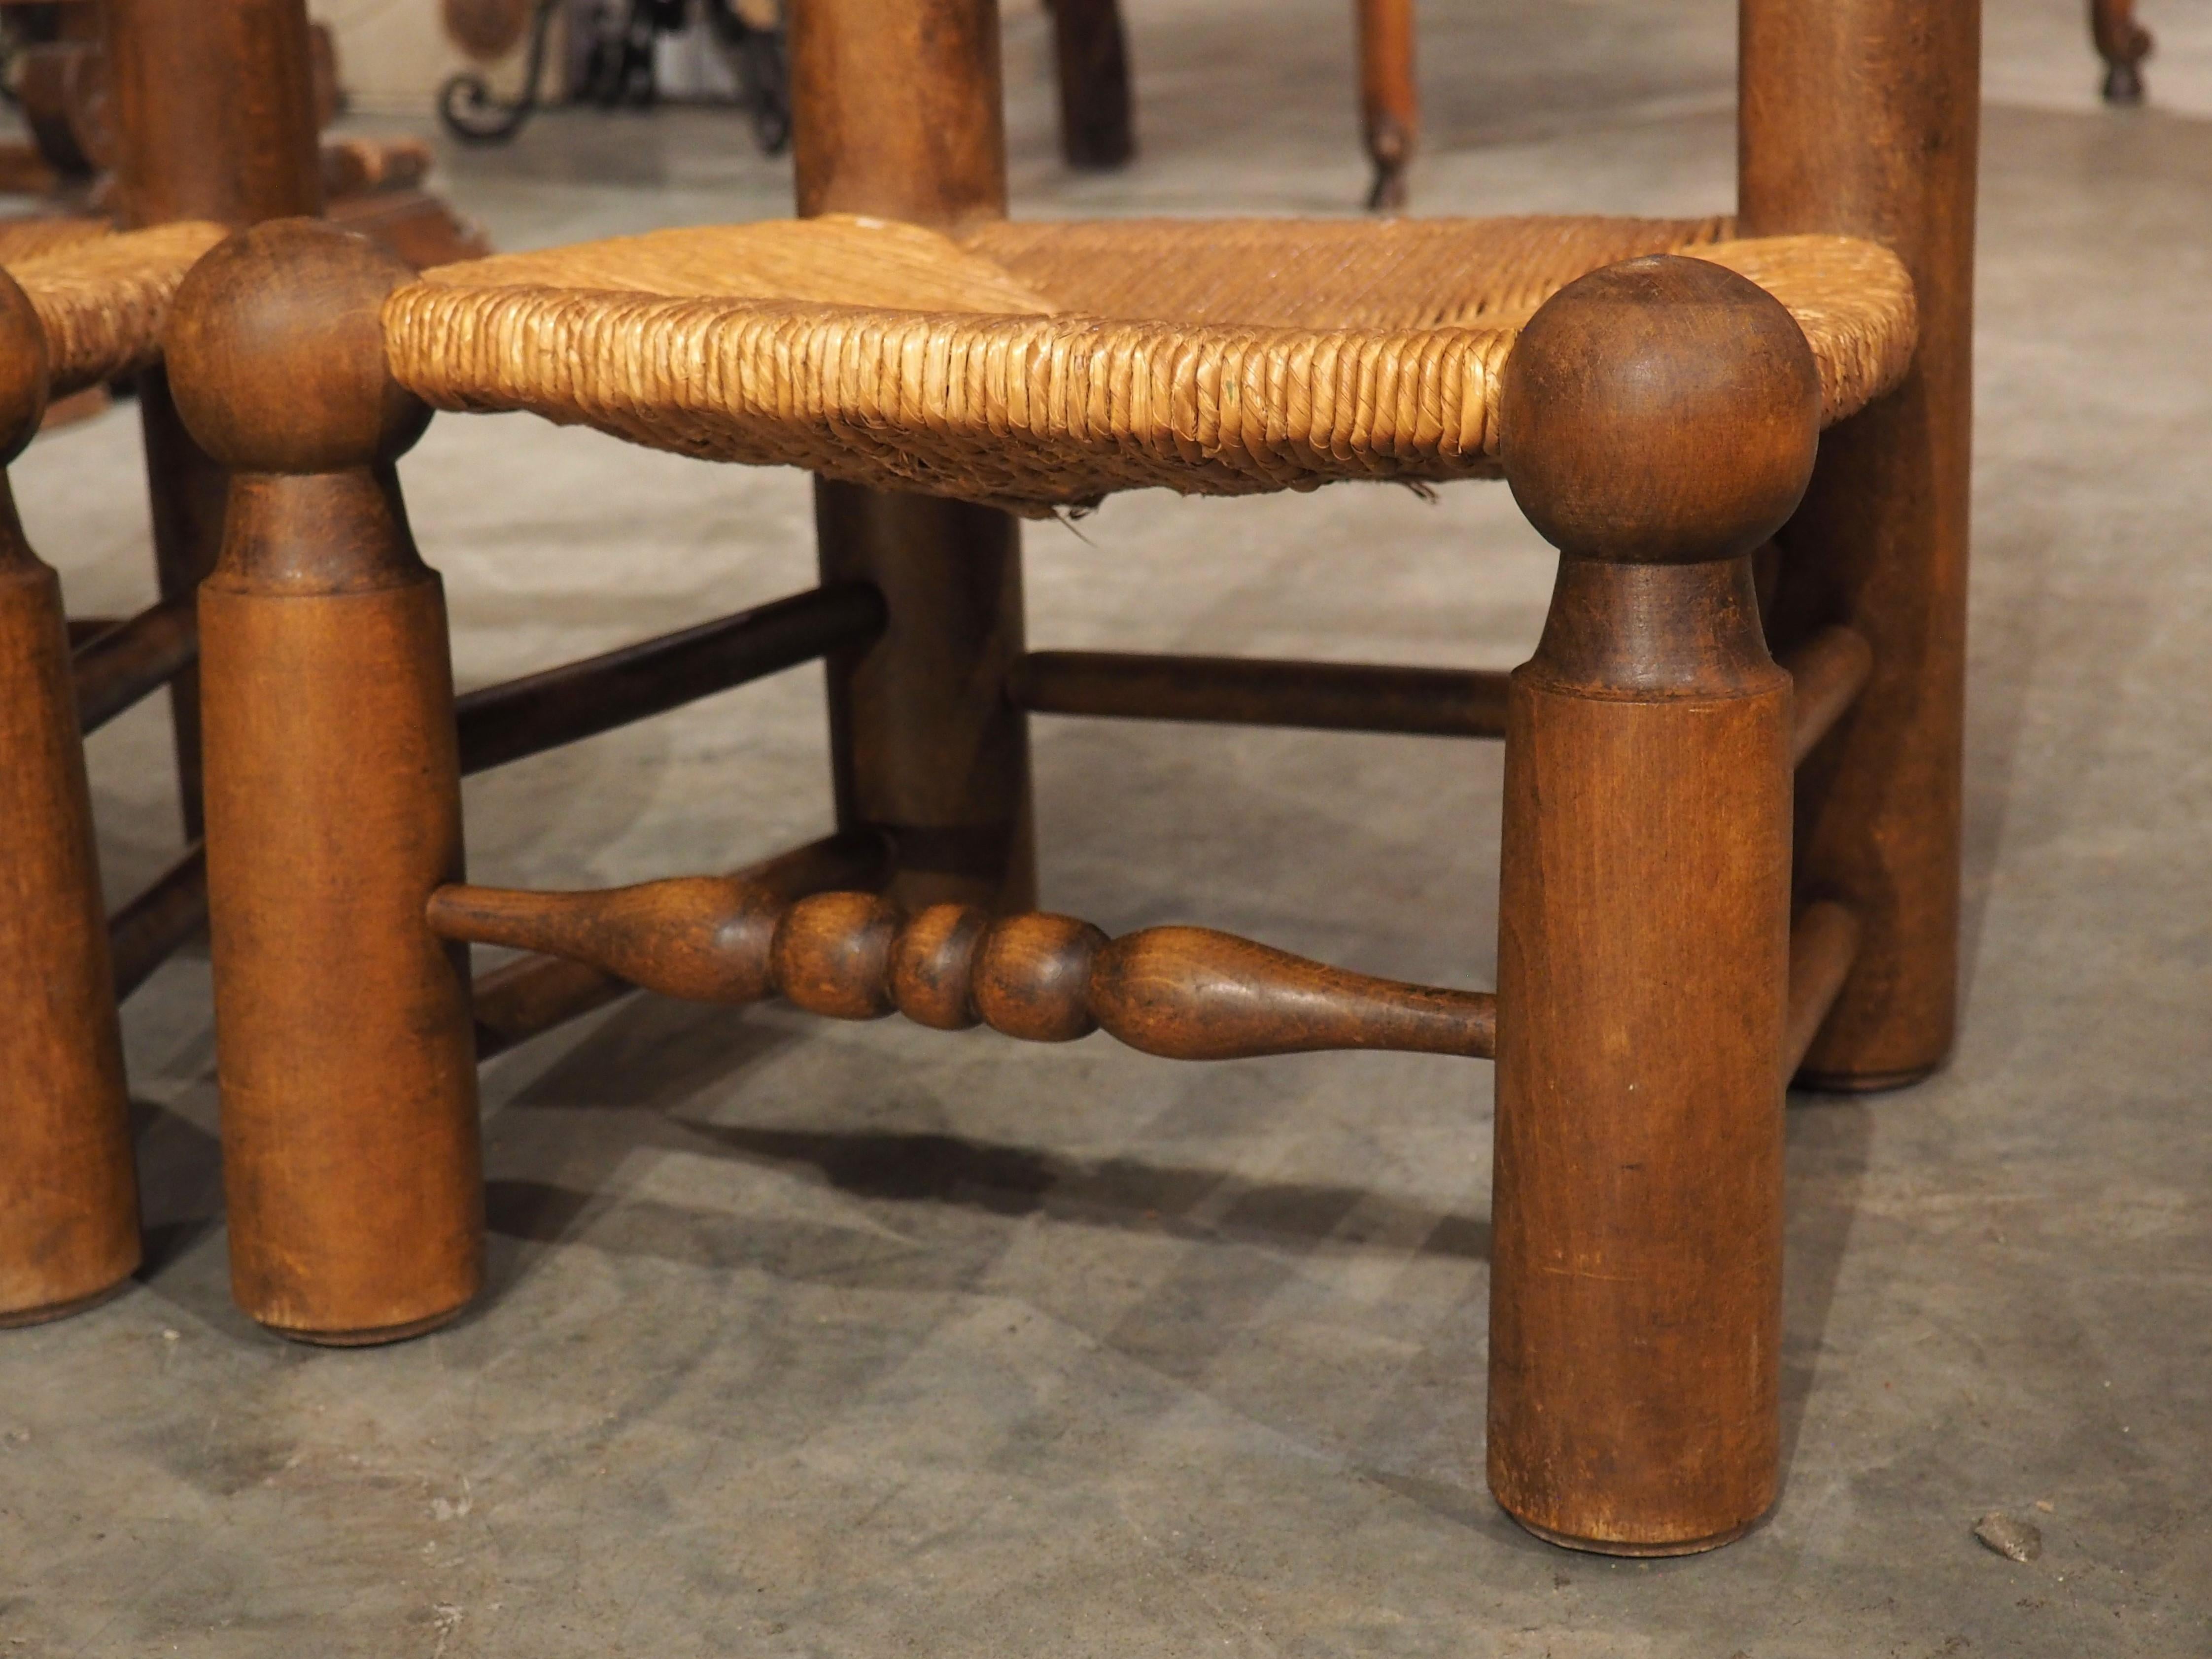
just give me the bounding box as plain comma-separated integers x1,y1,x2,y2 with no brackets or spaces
0,0,354,1325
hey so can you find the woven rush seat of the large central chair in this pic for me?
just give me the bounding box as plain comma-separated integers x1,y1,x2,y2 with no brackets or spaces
385,217,1916,516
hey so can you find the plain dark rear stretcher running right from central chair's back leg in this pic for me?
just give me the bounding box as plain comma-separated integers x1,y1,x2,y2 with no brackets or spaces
1009,650,1509,737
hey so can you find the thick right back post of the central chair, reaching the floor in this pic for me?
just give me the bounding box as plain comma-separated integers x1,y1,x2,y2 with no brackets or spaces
1739,0,1982,1088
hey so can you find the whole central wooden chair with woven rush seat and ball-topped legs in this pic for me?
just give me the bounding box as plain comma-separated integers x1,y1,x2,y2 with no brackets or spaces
168,0,1977,1555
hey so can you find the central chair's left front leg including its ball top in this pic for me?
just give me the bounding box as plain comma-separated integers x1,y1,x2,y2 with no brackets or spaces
168,219,482,1343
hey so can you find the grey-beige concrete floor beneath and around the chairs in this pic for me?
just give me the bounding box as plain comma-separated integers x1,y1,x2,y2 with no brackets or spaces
0,0,2212,1659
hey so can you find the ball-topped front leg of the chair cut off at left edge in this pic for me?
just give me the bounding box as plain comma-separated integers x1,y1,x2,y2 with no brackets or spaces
0,275,139,1325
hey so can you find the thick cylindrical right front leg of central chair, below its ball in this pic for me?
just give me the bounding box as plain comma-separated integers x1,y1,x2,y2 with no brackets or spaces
1488,557,1790,1555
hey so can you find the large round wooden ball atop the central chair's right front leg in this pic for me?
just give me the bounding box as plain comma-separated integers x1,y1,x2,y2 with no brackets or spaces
1502,254,1821,564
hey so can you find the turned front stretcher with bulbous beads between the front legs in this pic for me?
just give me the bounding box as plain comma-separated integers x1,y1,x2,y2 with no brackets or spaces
427,876,1495,1060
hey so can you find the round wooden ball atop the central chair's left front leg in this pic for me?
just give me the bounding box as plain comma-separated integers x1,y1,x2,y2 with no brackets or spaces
164,219,429,473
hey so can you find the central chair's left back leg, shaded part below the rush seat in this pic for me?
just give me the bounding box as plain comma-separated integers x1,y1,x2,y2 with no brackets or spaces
814,480,1037,911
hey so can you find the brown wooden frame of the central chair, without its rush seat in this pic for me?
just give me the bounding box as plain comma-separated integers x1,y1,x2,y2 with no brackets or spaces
171,0,1980,1555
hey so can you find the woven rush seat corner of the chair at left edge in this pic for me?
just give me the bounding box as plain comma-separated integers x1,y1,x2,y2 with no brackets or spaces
0,219,230,398
